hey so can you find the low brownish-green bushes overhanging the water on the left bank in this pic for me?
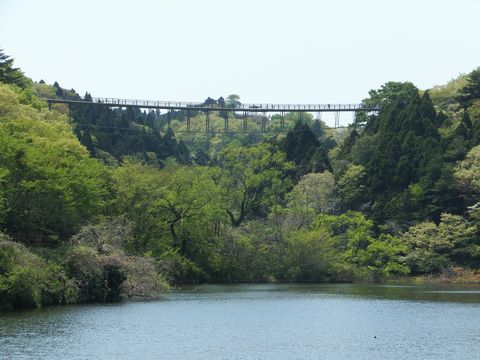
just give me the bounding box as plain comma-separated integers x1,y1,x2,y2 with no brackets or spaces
0,222,168,309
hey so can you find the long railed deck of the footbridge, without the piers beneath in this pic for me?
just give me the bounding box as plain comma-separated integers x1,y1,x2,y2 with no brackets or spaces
44,97,380,113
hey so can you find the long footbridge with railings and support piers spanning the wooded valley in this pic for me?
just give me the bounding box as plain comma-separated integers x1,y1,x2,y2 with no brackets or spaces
44,97,380,133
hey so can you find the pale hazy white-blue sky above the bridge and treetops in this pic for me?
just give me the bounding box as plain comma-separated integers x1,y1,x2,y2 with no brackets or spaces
0,0,480,103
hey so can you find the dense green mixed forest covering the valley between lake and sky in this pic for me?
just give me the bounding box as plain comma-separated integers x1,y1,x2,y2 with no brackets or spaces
0,51,480,308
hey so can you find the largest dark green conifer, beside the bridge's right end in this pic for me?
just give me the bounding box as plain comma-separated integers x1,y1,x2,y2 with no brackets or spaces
341,83,450,223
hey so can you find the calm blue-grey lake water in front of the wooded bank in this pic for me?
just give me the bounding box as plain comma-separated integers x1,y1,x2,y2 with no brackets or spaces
0,285,480,360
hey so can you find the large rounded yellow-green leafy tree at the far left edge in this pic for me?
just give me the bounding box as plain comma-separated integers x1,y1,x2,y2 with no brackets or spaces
0,85,108,242
